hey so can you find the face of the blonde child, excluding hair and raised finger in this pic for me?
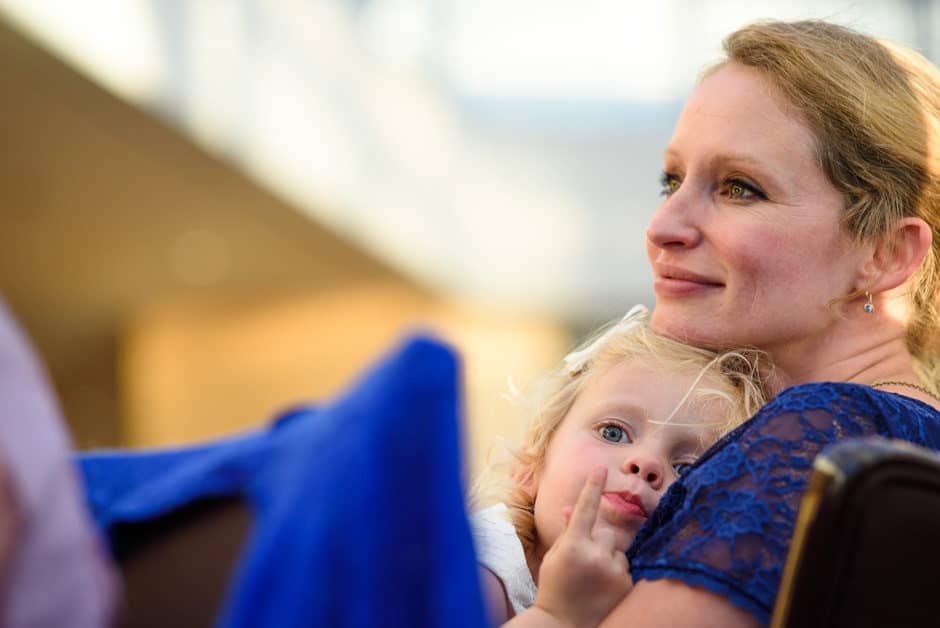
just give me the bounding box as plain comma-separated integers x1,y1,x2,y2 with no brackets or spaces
535,362,724,554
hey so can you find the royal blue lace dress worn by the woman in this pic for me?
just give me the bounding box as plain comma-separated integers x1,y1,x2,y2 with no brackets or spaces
627,383,940,624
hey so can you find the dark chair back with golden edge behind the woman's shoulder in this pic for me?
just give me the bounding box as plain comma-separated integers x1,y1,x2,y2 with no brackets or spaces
771,439,940,628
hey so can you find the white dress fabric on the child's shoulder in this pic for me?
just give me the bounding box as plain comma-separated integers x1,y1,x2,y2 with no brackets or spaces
470,504,535,614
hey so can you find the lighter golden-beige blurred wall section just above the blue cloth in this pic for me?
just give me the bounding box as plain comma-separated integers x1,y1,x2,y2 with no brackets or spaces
121,283,567,473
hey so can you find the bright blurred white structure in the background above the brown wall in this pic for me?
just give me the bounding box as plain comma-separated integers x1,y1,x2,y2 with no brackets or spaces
0,0,940,324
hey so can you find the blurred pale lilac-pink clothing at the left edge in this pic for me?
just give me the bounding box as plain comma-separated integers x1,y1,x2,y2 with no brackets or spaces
0,299,117,628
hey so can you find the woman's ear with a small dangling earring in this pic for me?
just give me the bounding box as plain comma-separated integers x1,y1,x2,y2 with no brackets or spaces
861,217,933,292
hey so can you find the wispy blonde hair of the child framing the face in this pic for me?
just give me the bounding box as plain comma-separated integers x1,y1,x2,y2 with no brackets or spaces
471,308,767,553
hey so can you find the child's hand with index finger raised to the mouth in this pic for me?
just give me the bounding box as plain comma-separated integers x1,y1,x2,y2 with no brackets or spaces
535,467,633,628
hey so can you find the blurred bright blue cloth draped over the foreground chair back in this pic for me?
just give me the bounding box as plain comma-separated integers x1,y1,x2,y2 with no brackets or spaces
79,338,486,628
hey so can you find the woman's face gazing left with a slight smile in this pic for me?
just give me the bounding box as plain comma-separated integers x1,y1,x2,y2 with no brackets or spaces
646,63,864,357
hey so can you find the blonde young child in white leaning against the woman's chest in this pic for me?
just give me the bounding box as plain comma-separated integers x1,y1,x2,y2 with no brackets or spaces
471,306,765,626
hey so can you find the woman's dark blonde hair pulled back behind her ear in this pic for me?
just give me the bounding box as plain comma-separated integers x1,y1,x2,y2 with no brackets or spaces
709,21,940,372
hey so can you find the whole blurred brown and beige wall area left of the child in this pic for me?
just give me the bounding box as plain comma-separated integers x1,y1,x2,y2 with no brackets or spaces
0,21,565,474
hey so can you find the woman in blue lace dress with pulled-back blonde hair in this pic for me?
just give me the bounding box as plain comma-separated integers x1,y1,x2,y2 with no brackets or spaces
588,22,940,626
